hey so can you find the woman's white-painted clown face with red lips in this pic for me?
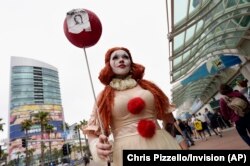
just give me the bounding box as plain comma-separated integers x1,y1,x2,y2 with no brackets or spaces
109,50,131,76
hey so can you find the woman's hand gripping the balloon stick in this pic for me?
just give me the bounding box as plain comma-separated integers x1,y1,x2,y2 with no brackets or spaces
96,134,112,160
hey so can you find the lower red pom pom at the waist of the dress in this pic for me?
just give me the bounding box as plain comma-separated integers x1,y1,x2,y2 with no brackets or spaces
137,119,156,138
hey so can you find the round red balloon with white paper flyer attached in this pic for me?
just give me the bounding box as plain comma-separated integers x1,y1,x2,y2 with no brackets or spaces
63,9,102,48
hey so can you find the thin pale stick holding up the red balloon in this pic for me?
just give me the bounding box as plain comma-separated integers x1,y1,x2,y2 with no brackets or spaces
83,48,105,135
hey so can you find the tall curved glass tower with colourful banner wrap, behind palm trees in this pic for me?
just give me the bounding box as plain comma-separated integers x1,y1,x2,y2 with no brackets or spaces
8,57,64,164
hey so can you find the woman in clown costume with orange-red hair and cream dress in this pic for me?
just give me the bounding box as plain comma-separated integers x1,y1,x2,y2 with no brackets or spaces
83,47,181,166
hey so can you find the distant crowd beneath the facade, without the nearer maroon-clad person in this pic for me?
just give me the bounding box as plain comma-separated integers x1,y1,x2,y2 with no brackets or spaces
165,108,232,149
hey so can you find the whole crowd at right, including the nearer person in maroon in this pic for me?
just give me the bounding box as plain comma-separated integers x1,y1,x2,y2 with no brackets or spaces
166,80,250,147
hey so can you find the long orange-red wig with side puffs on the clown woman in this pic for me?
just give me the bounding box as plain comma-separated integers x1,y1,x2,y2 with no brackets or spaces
97,47,173,135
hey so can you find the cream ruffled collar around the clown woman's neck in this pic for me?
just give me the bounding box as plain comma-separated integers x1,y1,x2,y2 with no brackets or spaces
109,75,137,90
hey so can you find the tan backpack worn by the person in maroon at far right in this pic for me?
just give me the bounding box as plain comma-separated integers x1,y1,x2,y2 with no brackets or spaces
224,96,250,117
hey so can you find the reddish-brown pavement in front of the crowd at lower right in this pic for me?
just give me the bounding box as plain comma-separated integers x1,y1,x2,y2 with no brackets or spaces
190,127,250,150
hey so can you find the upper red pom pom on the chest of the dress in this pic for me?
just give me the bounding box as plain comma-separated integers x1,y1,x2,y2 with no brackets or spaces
127,97,145,114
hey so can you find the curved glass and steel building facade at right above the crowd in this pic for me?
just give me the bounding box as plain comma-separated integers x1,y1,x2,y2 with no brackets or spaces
166,0,250,112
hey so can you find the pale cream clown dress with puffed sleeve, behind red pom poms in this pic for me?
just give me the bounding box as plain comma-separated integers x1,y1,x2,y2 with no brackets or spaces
84,78,181,166
